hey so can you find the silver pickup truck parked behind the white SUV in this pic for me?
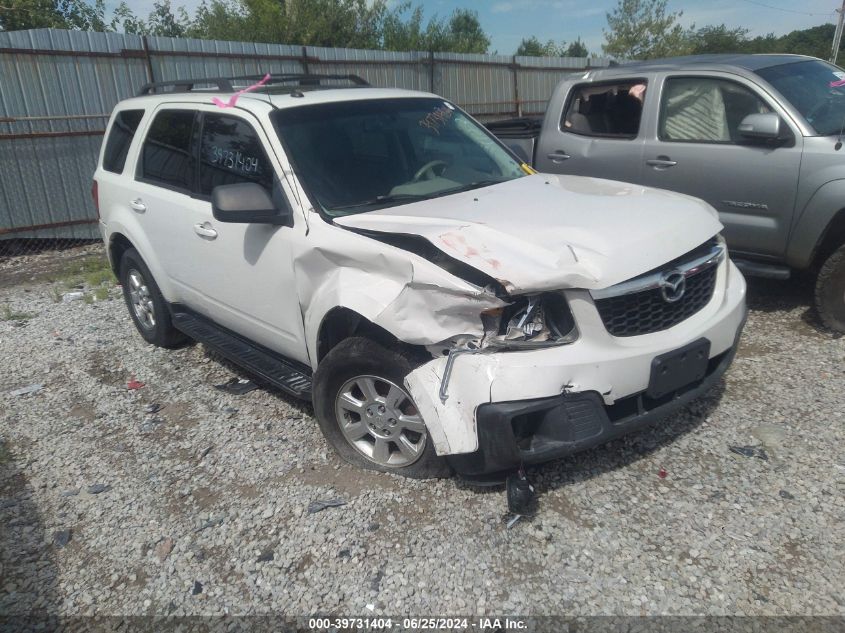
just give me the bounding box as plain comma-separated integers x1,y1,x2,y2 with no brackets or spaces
488,55,845,332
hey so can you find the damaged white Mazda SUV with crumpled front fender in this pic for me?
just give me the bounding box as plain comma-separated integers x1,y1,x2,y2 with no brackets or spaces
94,75,746,479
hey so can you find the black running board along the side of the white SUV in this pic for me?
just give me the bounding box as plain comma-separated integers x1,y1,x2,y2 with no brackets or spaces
171,306,311,400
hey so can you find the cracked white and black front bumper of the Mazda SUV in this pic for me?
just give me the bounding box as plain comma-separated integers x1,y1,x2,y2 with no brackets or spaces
405,260,746,475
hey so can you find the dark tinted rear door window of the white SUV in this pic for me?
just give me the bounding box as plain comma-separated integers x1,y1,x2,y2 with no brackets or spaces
140,110,195,190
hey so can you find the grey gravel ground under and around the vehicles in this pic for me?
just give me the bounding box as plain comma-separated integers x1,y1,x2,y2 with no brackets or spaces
0,246,845,616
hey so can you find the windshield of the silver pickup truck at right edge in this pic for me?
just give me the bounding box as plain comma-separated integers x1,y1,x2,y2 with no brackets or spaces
757,59,845,136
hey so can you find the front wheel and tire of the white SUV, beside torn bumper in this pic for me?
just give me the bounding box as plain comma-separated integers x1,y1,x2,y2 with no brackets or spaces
313,337,452,479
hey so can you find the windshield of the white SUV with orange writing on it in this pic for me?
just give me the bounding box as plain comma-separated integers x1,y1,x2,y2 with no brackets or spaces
272,98,525,217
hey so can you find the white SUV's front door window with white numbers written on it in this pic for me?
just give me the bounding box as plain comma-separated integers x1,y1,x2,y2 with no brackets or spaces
199,114,273,196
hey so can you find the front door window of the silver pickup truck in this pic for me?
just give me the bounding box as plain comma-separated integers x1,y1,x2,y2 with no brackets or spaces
658,77,771,143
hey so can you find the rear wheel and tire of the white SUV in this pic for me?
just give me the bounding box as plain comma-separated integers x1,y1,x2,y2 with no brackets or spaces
120,248,187,347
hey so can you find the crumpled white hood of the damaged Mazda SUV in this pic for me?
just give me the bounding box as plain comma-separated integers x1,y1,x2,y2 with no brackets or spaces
335,174,722,293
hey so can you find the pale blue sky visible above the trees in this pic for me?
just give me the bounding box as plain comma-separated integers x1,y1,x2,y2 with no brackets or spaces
117,0,840,55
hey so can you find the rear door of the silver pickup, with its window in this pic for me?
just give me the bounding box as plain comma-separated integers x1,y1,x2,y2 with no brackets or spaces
534,76,651,182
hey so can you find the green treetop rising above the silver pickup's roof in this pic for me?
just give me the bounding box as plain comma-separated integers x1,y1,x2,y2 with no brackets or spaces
602,0,690,59
